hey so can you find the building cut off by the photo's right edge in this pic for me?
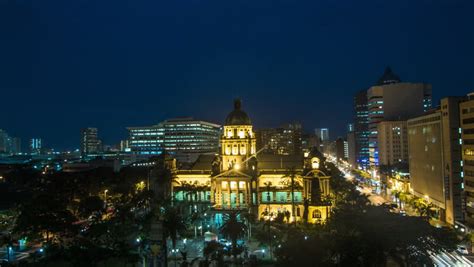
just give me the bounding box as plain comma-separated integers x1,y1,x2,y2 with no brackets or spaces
459,93,474,227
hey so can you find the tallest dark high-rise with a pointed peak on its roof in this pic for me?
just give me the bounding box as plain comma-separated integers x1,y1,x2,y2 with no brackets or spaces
367,68,431,166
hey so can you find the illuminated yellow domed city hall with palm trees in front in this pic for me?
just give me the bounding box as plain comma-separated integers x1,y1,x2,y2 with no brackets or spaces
172,100,331,224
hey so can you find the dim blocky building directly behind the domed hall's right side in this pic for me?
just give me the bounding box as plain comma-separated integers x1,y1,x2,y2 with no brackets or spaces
255,123,302,155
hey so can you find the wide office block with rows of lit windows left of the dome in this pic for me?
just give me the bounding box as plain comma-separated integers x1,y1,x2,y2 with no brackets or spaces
126,118,220,161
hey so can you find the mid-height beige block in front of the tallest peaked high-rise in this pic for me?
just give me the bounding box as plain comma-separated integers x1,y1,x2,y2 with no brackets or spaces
377,121,408,166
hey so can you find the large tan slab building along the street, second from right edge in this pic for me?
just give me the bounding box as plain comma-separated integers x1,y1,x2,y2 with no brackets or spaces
407,97,467,225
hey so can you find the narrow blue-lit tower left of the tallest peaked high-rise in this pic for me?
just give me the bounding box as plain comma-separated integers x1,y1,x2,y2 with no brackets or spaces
353,90,369,168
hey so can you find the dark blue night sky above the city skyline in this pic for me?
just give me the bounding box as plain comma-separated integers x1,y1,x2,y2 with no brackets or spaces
0,0,474,149
